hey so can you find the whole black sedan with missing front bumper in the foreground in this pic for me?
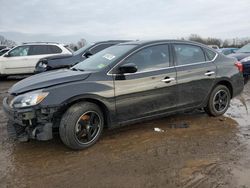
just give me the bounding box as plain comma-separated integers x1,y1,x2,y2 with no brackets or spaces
3,40,244,149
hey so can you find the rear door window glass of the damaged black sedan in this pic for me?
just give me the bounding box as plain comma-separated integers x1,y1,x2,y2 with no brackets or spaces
174,44,206,65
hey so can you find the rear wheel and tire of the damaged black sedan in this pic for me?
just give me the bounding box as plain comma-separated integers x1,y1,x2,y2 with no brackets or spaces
204,85,231,117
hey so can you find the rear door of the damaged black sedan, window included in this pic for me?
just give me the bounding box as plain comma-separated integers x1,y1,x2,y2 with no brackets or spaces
173,43,216,109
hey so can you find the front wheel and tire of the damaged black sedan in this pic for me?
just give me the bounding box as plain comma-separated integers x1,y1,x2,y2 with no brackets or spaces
59,102,104,150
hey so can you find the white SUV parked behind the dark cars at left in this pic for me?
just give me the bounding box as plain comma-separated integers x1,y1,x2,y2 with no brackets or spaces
0,42,72,78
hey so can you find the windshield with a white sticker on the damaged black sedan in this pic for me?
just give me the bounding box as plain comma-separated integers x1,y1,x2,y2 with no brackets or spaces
72,45,135,71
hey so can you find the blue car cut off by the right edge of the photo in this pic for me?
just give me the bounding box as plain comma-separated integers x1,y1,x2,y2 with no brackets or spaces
229,43,250,83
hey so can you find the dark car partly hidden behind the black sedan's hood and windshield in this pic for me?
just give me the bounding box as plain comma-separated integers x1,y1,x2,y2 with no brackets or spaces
36,40,131,73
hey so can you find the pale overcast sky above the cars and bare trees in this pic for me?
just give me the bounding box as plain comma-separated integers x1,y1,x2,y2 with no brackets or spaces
0,0,250,40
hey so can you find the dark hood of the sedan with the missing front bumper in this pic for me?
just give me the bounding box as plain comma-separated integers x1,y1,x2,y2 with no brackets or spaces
9,69,91,95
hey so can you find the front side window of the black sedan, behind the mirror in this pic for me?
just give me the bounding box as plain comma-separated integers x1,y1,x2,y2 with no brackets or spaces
123,44,170,72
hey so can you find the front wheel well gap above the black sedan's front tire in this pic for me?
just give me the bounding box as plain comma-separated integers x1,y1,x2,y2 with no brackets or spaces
61,98,110,127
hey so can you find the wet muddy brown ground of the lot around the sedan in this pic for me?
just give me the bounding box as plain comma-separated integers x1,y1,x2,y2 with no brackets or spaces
0,79,250,188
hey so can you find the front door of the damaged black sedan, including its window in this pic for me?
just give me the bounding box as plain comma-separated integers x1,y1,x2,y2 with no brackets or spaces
113,44,177,122
